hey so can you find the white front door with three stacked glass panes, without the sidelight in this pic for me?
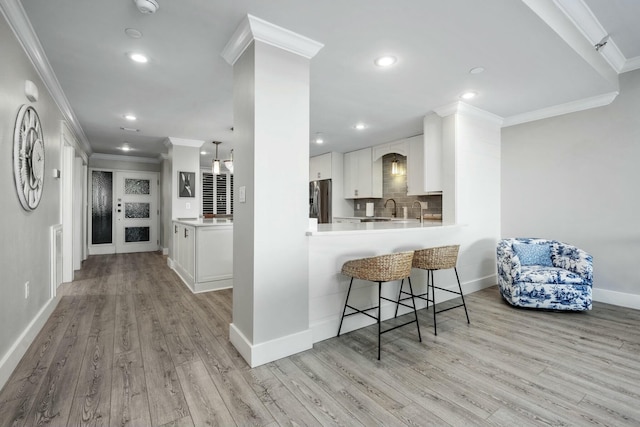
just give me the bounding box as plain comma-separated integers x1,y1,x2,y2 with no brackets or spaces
114,171,158,253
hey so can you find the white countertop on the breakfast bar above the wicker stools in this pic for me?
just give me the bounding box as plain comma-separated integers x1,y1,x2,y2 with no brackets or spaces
307,220,448,236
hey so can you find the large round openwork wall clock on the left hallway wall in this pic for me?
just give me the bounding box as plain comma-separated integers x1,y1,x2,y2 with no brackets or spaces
13,105,44,211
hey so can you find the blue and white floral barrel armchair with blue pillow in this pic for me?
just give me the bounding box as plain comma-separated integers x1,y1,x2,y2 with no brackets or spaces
497,238,593,310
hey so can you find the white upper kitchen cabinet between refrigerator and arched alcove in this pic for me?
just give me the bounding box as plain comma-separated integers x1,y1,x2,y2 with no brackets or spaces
344,147,382,199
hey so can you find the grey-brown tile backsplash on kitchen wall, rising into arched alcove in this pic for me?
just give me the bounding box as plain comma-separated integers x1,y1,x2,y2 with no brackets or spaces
353,154,442,218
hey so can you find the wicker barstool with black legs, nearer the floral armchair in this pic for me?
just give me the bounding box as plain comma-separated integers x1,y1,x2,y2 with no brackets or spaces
396,245,471,335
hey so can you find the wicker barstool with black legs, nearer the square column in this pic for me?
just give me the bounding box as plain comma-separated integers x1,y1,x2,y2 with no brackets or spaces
338,251,422,360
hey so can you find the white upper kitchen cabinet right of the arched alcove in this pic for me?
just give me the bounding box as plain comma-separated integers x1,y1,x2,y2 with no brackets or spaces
407,114,442,196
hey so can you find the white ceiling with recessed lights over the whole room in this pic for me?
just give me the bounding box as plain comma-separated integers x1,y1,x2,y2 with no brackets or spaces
8,0,640,166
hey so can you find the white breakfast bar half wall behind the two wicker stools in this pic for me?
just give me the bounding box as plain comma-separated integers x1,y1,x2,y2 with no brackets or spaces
307,221,495,342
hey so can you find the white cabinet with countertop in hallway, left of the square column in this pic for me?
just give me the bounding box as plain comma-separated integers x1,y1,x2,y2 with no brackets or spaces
167,218,233,293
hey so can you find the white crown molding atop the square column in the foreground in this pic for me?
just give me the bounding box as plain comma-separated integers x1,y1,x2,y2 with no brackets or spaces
221,14,324,65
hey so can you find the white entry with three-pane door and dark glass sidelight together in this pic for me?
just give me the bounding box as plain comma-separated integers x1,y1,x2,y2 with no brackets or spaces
89,169,159,255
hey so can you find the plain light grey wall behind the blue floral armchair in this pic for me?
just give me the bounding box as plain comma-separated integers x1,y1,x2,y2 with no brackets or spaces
501,70,640,308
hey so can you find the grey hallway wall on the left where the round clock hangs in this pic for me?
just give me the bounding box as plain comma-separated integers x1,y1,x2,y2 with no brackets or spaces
0,15,63,387
